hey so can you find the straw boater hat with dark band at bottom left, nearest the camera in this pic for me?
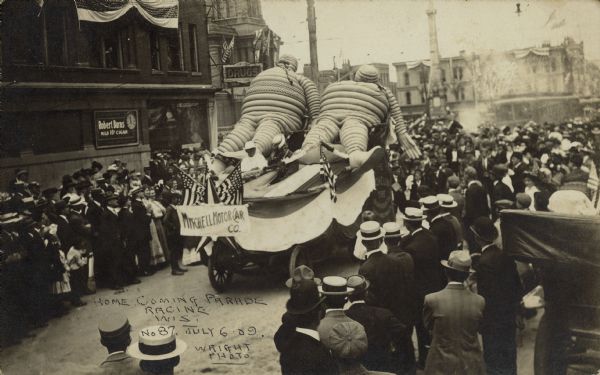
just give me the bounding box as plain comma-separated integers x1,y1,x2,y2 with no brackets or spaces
127,326,187,361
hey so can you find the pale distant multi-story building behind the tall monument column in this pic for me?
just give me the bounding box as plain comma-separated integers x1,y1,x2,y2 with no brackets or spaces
393,38,586,123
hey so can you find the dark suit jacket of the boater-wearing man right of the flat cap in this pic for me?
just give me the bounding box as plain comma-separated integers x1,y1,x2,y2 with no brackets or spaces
346,303,412,372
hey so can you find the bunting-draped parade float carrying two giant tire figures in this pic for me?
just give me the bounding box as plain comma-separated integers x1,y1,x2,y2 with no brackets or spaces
190,63,420,291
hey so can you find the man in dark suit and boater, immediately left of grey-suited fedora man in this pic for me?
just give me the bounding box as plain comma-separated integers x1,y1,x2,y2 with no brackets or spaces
402,207,444,367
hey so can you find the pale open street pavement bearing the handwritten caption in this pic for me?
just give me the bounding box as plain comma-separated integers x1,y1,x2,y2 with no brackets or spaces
0,255,538,375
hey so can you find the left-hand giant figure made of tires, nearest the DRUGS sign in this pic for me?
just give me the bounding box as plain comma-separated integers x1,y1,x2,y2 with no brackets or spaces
218,55,320,173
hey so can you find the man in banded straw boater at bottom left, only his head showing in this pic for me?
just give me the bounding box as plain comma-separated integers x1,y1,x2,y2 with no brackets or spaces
127,325,187,375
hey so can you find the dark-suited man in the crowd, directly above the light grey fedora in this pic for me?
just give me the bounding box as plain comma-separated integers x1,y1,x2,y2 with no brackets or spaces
463,167,490,254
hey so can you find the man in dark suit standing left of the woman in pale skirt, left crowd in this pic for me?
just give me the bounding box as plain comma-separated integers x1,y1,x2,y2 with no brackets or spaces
127,187,154,276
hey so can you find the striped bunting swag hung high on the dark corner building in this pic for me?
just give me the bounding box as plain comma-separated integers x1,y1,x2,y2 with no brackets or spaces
75,0,179,29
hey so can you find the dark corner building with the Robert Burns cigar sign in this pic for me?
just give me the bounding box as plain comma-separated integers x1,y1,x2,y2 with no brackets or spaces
0,0,214,186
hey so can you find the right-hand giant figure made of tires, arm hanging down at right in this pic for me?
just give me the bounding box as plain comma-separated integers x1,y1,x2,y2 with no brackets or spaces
302,65,421,168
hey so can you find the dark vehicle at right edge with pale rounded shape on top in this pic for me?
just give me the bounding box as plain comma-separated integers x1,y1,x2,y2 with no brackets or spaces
501,195,600,375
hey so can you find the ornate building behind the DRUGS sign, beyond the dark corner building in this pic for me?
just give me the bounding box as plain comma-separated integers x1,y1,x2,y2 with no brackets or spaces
205,0,283,136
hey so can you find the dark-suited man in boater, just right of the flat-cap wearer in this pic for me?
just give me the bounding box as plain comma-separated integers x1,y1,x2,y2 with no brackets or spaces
346,275,415,374
